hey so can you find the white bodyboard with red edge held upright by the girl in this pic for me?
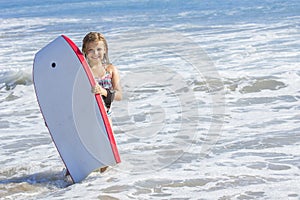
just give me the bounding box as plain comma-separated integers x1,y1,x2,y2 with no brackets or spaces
33,35,120,183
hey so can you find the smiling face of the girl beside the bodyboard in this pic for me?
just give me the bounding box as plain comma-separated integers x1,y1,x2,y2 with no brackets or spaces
86,41,106,65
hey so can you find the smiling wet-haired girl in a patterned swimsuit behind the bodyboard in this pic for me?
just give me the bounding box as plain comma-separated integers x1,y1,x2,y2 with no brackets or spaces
82,32,122,119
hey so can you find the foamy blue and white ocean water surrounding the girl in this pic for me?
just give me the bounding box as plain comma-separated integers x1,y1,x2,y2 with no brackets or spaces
0,0,300,200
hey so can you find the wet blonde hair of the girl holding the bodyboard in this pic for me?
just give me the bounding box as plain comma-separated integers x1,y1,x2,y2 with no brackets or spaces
82,32,110,64
